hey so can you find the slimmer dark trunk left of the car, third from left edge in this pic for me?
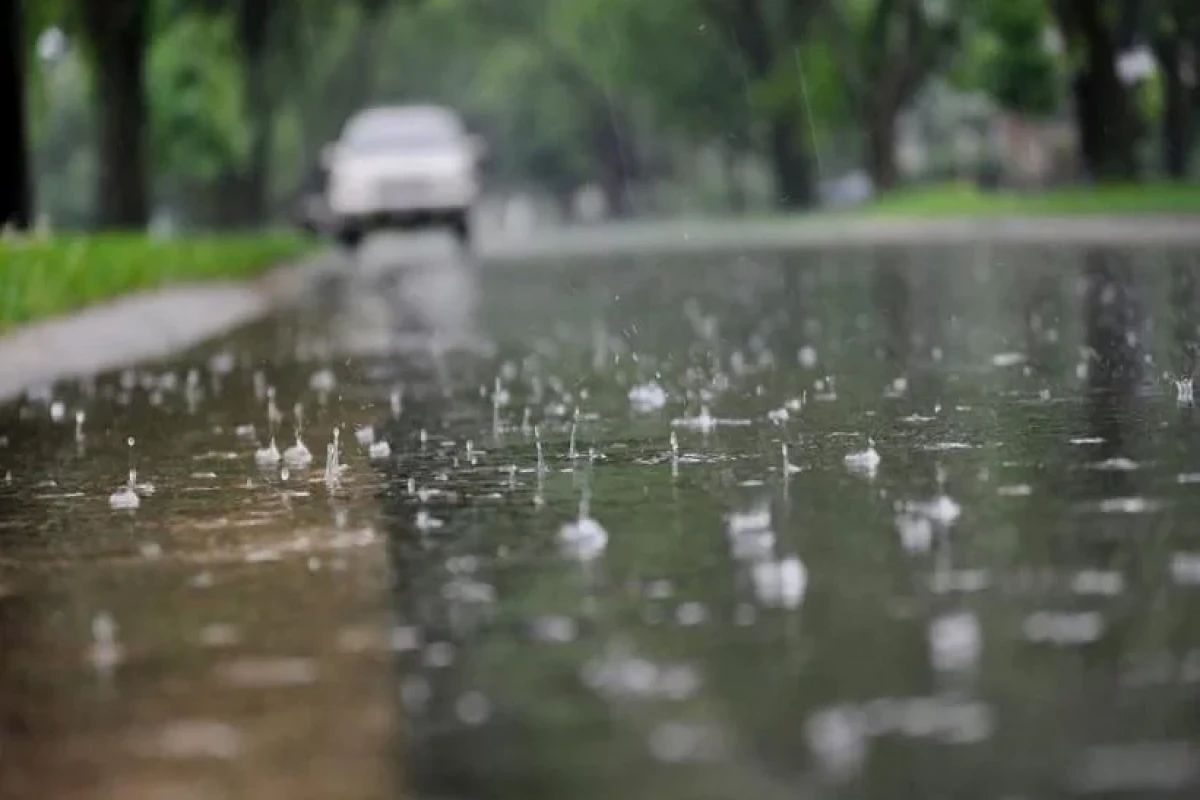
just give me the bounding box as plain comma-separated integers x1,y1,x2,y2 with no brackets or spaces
238,0,275,224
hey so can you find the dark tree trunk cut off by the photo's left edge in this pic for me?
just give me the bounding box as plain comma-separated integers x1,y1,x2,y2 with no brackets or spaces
0,0,32,229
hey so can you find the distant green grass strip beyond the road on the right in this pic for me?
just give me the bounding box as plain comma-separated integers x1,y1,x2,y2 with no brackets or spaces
860,184,1200,217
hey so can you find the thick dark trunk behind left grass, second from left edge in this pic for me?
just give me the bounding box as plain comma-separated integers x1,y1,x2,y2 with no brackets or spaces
79,0,150,229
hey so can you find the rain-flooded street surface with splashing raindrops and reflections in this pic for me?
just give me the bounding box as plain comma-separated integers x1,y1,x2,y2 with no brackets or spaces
7,240,1200,799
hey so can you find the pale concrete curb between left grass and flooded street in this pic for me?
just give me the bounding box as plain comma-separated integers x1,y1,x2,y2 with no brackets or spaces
0,252,337,403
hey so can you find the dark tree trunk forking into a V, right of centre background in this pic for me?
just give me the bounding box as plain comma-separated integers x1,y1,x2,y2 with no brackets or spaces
824,0,967,191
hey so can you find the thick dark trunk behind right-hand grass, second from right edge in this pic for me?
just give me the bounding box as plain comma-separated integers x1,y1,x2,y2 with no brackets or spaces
1052,0,1138,181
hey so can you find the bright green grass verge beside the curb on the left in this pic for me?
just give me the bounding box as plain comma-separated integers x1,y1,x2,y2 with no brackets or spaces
0,234,313,331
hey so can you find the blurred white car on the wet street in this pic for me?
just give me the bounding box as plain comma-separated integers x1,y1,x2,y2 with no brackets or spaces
322,106,484,247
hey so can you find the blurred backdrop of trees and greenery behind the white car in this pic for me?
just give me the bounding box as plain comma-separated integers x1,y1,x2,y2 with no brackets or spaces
0,0,1200,237
